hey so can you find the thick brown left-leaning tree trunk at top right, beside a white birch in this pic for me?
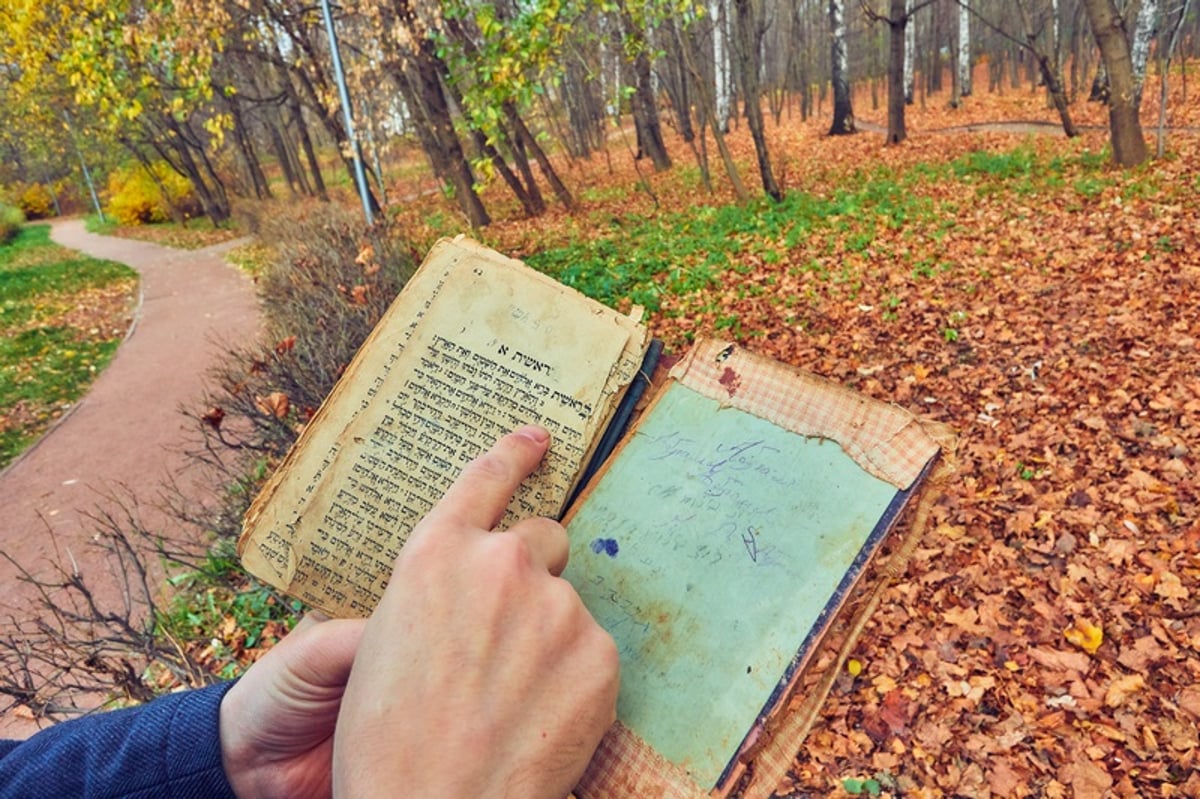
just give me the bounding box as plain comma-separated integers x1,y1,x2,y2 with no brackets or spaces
1084,0,1147,167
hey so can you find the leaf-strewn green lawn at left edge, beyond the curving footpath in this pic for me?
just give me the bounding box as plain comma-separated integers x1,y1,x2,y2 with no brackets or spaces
0,226,137,467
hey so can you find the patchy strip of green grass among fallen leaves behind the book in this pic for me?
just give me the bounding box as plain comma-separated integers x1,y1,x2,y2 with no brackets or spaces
526,145,1164,316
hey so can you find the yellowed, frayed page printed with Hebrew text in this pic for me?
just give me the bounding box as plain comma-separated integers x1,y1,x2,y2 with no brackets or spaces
239,239,646,615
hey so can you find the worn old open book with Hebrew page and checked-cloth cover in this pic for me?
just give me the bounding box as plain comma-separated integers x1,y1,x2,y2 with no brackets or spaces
239,238,938,798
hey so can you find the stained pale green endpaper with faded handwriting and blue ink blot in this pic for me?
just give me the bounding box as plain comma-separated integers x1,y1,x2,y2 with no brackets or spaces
564,383,896,789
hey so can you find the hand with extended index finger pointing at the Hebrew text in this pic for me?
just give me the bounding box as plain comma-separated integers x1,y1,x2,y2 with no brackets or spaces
334,427,619,799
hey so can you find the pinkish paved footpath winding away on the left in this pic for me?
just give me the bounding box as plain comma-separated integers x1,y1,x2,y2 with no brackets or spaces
0,220,259,738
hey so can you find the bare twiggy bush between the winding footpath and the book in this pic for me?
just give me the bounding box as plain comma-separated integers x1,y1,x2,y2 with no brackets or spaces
0,204,415,721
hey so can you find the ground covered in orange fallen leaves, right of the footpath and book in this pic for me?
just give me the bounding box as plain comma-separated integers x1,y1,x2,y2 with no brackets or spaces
388,82,1200,799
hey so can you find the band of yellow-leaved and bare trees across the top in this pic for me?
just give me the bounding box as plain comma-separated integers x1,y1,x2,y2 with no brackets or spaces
0,0,1200,220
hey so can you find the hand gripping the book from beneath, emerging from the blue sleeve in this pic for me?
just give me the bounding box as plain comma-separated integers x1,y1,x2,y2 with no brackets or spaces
220,615,366,799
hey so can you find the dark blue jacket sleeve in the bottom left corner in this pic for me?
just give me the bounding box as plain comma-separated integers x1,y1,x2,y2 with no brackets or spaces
0,683,234,799
